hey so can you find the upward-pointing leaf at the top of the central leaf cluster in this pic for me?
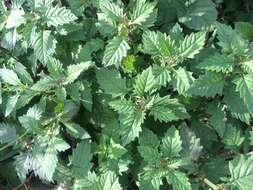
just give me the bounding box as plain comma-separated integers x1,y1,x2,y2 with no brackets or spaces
134,67,156,96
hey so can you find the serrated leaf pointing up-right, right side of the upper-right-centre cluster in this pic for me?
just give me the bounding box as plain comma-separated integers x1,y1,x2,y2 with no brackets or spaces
178,32,206,59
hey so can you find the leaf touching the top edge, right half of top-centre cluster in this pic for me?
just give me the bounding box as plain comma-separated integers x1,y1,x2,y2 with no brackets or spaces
131,0,157,28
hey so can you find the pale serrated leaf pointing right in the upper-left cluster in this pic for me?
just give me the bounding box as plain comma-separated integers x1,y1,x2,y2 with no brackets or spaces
43,6,77,27
